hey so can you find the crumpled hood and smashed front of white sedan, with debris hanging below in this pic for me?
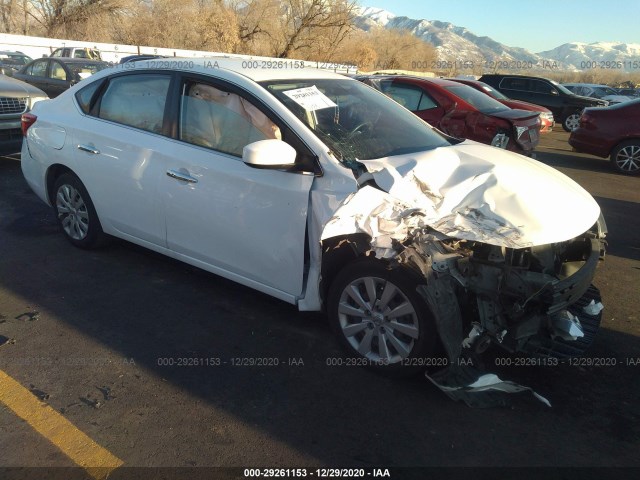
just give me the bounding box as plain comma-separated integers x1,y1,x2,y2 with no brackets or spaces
322,145,607,406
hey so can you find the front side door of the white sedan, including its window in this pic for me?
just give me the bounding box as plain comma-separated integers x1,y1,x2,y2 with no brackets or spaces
160,80,314,302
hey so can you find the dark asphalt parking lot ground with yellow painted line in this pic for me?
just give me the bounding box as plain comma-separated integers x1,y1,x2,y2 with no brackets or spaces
0,127,640,478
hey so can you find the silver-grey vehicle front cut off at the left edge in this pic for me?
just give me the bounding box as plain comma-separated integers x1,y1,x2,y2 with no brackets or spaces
0,75,47,155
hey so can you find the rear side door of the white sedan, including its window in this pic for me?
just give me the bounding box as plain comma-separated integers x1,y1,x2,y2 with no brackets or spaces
74,74,171,247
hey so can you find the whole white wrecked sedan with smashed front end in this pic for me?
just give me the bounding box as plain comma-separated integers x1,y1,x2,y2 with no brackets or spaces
22,58,606,380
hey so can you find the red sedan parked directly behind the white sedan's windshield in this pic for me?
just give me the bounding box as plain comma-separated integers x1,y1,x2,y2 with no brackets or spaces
356,75,540,155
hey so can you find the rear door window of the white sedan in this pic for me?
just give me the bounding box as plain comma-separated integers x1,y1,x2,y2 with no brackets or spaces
98,75,171,133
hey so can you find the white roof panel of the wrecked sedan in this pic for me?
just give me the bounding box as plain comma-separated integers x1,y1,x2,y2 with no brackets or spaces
119,56,347,82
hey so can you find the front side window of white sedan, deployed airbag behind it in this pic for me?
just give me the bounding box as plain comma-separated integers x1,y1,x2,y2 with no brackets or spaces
179,82,282,157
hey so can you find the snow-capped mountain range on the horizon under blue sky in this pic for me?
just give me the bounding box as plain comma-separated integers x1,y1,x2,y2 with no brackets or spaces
356,7,640,71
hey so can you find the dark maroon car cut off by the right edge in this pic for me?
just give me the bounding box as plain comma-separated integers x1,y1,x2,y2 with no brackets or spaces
569,99,640,175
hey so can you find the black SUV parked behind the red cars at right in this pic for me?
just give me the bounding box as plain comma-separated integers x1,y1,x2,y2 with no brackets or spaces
479,74,609,132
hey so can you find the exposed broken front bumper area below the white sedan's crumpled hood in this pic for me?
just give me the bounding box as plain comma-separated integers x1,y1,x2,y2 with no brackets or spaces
396,219,606,361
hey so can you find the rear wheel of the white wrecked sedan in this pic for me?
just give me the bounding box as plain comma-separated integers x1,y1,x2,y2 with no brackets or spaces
53,173,105,249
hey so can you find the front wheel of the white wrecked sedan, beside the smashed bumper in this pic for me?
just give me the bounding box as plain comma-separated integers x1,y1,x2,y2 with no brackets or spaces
328,258,436,376
